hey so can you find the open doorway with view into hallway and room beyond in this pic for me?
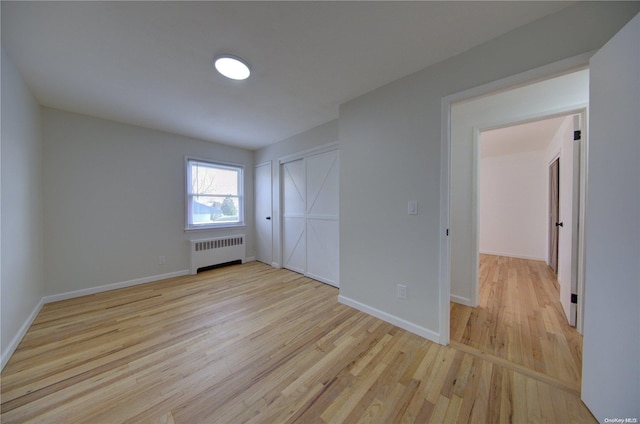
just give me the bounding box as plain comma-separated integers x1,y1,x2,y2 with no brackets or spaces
449,70,588,390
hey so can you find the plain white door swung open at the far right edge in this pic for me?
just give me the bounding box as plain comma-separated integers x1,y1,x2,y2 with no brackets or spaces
582,11,640,422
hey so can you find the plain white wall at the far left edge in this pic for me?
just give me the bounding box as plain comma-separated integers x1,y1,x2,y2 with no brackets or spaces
0,51,44,367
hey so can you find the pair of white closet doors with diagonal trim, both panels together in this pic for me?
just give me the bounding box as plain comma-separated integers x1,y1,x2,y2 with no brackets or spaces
281,151,340,287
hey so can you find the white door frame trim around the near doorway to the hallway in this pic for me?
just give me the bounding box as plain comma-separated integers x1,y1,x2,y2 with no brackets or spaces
439,52,594,345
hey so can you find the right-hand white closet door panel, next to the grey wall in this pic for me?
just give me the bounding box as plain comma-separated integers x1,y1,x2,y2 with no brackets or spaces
306,151,340,287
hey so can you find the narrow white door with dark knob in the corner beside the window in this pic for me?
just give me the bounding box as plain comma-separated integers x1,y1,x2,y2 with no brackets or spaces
255,162,273,265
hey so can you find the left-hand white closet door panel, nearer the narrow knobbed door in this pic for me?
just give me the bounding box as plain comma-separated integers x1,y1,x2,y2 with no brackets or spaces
282,159,307,274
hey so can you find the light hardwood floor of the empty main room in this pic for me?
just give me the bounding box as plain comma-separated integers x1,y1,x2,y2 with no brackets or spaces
0,262,594,424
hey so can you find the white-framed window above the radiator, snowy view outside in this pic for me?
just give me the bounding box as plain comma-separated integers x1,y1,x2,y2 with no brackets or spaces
187,158,244,230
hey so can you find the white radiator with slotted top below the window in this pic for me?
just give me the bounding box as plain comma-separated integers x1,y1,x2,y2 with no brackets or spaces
190,234,245,274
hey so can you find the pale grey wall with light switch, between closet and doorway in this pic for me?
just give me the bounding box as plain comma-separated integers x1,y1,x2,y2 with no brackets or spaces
339,3,638,340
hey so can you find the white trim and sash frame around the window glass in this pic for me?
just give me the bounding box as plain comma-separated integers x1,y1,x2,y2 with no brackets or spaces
184,156,246,231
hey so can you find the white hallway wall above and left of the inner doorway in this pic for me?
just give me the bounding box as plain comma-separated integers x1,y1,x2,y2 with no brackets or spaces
451,70,589,305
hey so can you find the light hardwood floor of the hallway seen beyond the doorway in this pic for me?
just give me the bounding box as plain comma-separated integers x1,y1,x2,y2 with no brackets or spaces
451,255,582,393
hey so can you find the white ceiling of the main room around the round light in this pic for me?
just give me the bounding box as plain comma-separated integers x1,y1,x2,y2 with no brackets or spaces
1,1,570,149
